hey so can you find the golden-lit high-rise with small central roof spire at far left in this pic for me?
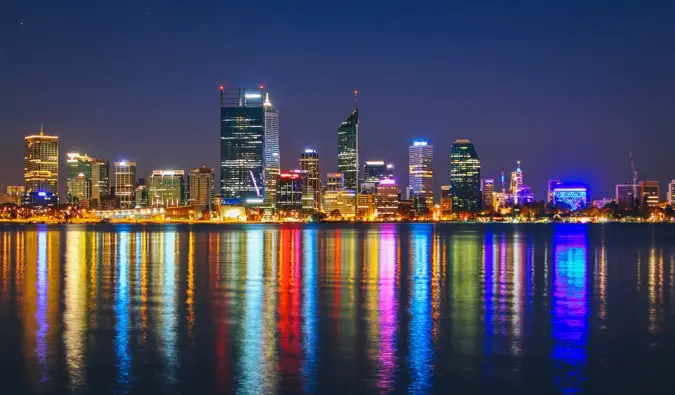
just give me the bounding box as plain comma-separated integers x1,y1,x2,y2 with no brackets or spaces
23,127,59,195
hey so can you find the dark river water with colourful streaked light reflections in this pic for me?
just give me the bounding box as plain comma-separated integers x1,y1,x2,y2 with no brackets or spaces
0,224,675,394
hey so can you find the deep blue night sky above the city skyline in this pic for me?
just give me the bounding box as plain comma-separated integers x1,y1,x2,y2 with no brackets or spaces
0,0,675,199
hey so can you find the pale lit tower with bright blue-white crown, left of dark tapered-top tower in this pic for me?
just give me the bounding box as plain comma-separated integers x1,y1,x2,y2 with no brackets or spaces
408,141,434,207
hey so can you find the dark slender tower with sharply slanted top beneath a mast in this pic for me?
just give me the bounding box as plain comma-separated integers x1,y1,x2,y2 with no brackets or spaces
338,109,359,192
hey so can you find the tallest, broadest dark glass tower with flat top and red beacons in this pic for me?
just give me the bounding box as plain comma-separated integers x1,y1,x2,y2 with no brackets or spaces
220,87,272,204
